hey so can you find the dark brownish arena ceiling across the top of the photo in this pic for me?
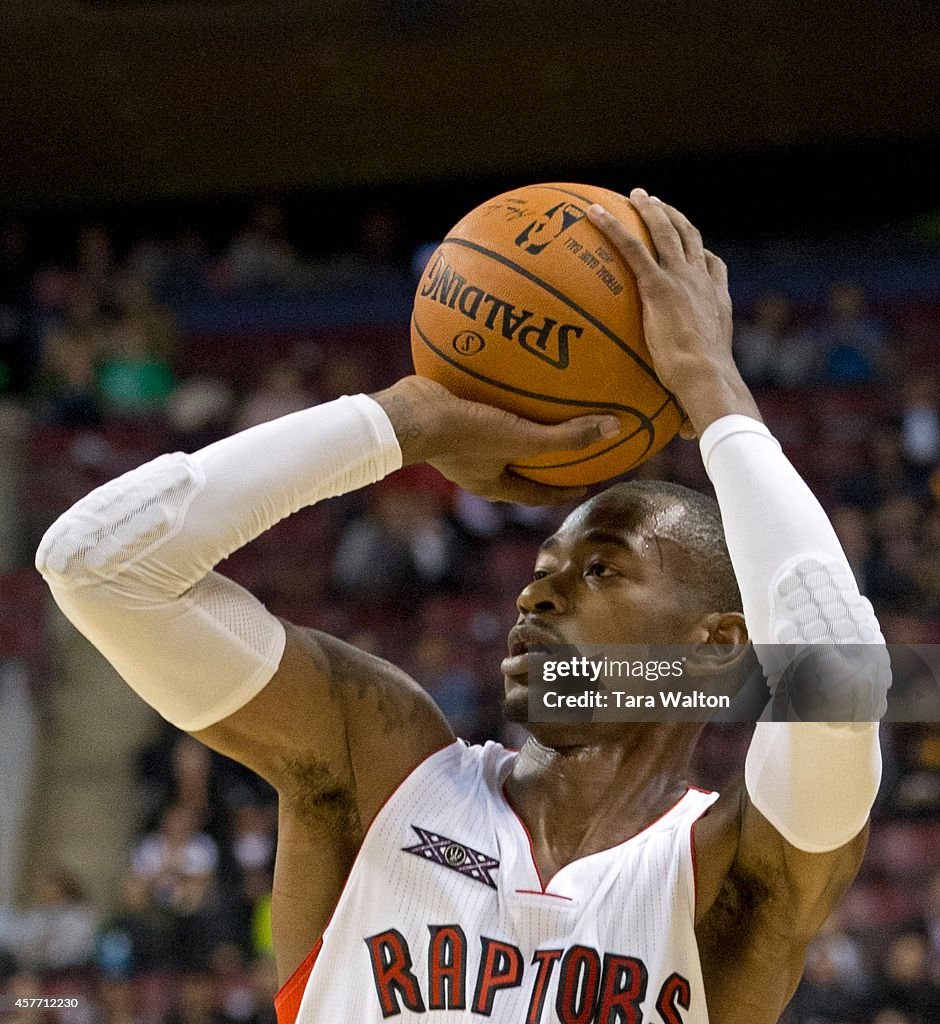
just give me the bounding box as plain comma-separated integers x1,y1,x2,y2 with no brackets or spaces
0,0,940,209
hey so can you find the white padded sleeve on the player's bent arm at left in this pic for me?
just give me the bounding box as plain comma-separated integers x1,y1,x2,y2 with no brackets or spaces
36,395,401,731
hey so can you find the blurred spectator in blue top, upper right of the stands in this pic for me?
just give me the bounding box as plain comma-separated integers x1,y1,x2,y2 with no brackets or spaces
812,281,888,384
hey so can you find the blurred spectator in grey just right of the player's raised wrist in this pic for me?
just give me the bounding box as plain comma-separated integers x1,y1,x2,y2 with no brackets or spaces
734,292,818,387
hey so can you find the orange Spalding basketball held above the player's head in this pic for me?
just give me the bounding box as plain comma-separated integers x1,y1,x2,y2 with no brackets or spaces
412,184,682,485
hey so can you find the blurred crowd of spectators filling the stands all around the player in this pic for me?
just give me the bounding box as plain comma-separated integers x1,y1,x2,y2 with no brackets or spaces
0,203,940,1024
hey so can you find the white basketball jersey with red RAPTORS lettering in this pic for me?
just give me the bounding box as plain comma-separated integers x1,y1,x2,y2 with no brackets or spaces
279,741,718,1024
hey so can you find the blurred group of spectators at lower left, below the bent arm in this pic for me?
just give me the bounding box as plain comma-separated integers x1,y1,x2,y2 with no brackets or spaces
0,729,277,1024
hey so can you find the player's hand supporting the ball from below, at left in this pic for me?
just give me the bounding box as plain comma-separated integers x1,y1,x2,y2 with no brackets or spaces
372,377,621,505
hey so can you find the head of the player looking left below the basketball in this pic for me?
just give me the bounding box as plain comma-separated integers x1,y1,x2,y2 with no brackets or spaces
504,480,746,721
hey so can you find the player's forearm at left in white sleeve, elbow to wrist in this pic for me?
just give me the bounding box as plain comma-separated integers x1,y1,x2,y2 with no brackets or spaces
37,395,400,594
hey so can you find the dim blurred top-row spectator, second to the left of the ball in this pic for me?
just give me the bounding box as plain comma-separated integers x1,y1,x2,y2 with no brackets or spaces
215,203,304,291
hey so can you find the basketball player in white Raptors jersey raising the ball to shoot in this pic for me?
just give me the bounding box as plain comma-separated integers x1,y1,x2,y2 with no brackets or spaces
37,190,882,1024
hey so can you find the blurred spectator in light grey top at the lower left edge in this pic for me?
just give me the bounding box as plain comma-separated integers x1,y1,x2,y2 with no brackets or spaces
0,869,97,971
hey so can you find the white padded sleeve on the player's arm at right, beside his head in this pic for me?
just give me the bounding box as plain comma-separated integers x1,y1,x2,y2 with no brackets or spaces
700,416,890,853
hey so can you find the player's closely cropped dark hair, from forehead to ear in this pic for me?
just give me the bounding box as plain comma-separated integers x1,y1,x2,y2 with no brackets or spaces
592,480,743,611
